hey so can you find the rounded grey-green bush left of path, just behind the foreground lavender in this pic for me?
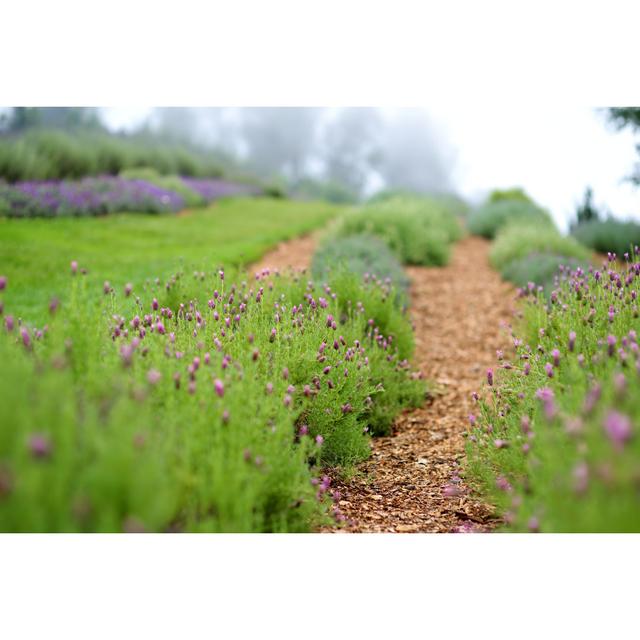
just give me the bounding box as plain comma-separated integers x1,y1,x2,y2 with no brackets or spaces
311,234,409,300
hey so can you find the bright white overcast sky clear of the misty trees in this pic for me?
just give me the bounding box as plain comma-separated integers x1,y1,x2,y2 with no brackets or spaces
104,107,640,230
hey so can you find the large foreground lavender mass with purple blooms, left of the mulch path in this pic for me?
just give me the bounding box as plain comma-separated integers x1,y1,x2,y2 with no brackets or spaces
0,261,424,532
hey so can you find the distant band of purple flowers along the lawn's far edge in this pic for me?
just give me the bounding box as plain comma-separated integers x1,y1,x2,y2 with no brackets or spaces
0,176,258,218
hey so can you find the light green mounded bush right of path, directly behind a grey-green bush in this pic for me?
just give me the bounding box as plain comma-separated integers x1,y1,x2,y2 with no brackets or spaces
489,224,591,271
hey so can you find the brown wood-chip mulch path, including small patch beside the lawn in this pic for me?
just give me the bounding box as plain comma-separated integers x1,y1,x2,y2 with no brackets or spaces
252,237,515,532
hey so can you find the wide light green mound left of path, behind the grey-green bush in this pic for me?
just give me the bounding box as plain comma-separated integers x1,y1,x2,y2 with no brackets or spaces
332,197,462,265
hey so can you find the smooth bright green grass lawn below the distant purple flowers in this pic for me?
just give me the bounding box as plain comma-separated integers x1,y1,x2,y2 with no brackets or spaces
0,198,339,321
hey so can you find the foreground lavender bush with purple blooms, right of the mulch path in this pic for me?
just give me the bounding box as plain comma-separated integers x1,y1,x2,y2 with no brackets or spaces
468,252,640,532
